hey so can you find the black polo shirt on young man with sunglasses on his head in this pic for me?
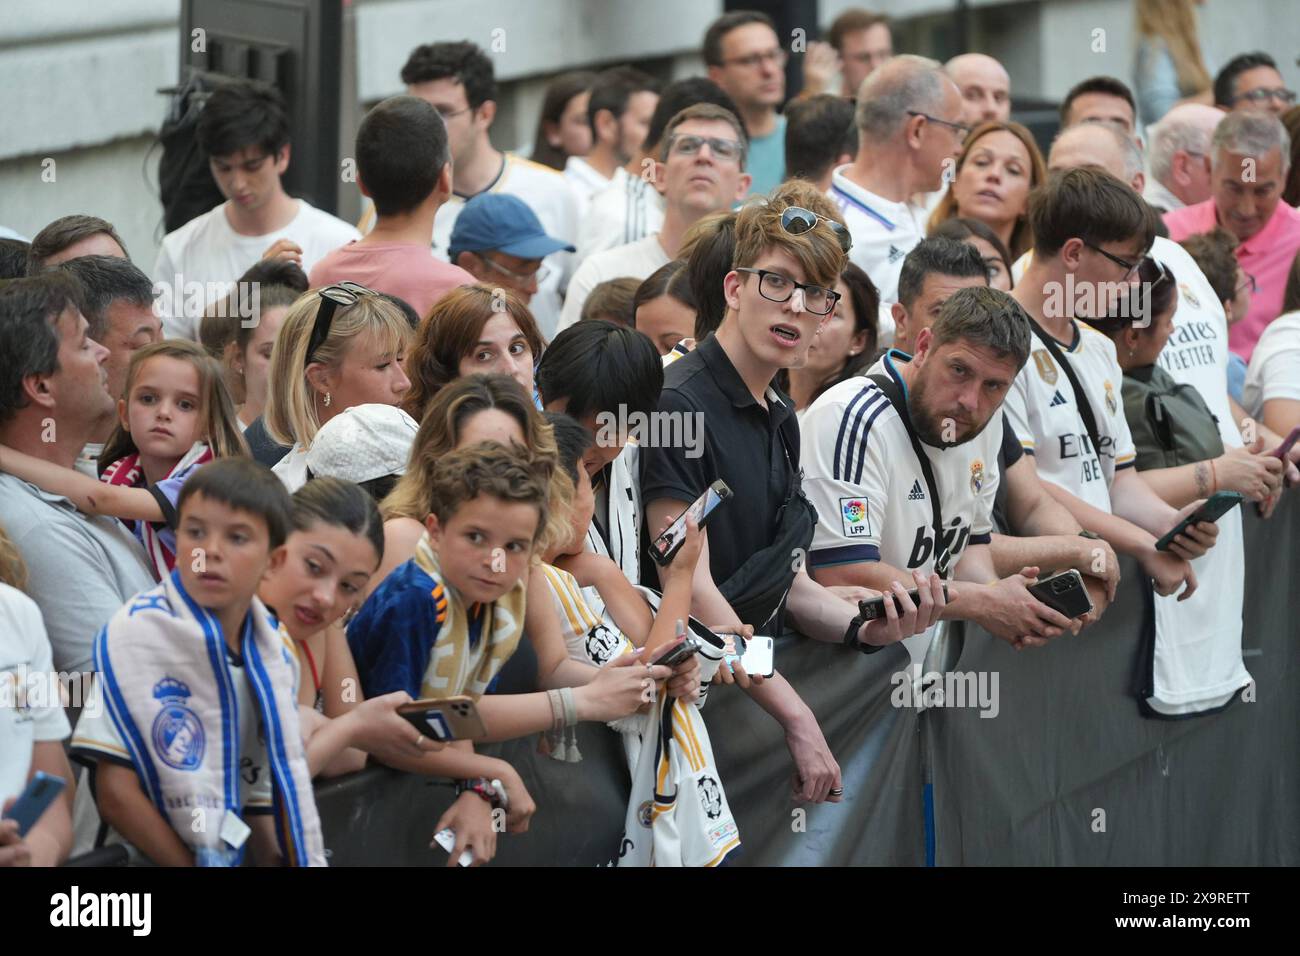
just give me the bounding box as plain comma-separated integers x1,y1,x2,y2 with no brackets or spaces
640,334,800,585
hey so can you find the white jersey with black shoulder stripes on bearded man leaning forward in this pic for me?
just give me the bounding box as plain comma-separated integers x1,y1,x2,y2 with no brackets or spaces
800,352,1002,663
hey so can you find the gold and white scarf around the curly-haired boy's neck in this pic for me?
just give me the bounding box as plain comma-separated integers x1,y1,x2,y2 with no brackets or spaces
415,533,527,697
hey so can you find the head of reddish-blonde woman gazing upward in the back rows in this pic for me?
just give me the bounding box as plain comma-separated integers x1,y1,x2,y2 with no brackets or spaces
928,120,1048,261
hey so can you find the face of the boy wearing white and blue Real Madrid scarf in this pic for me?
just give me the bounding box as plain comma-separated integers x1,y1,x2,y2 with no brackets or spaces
176,494,270,611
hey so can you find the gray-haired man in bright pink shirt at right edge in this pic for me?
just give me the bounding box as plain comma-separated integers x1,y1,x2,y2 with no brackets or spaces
1165,111,1300,362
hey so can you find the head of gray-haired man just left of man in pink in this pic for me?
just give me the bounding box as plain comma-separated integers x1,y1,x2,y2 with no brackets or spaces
1143,103,1223,212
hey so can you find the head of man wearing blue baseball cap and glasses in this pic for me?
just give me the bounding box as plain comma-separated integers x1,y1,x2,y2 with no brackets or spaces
447,193,573,306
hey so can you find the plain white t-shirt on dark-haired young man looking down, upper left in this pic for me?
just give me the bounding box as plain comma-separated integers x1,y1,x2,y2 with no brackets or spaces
153,199,361,342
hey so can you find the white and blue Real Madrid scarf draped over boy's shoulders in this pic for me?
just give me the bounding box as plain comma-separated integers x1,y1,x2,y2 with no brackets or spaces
95,572,326,866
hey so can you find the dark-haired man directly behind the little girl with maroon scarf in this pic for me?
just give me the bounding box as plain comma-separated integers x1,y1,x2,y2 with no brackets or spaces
56,255,163,477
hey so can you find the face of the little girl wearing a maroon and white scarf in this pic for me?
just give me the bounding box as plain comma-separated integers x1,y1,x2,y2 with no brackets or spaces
117,355,203,460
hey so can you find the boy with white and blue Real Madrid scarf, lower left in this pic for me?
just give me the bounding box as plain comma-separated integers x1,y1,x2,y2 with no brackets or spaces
72,458,325,866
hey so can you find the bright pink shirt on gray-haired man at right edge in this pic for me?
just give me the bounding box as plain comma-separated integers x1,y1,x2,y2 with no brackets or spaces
1165,199,1300,362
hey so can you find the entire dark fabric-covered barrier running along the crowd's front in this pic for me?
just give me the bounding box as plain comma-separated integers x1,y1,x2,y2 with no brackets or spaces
316,493,1300,865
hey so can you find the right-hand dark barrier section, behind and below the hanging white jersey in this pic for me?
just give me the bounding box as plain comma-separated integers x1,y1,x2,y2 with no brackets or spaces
924,492,1300,866
